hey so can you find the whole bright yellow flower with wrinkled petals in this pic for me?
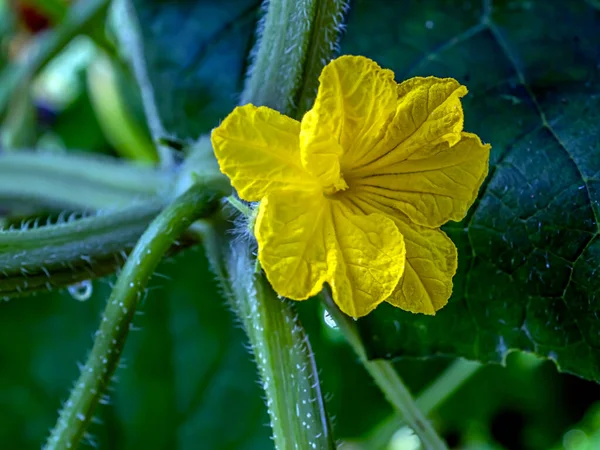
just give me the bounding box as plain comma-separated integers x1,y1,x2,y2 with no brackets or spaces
212,56,490,317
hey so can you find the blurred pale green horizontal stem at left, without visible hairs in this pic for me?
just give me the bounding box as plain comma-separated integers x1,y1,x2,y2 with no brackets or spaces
0,151,173,209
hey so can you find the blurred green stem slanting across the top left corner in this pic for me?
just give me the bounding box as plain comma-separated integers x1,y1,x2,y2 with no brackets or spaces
0,0,110,114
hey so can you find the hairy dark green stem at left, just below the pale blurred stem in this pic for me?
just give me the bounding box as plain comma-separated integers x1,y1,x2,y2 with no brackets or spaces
0,201,164,300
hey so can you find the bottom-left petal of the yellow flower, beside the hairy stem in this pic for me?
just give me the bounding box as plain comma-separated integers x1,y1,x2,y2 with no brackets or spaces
254,191,333,300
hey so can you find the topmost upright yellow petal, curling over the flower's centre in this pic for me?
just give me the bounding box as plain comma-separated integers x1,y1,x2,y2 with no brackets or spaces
300,55,398,186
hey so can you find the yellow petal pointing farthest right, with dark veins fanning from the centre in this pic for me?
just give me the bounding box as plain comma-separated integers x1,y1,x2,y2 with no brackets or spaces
350,133,490,228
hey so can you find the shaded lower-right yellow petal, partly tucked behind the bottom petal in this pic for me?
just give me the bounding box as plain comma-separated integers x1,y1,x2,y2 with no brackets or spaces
387,220,458,314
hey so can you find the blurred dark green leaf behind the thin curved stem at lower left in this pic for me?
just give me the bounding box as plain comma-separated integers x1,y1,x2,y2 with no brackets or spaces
0,250,272,450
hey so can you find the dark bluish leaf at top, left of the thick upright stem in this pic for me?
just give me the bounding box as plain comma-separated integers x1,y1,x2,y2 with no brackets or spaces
117,0,261,139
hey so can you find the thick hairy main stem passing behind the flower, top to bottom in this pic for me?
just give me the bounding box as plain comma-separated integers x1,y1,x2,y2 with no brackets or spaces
220,0,350,450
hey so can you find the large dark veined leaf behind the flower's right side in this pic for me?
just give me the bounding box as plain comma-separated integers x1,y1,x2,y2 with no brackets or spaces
342,0,600,381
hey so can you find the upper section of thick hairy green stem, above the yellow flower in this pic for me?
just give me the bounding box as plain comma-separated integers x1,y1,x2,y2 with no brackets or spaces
240,0,346,116
